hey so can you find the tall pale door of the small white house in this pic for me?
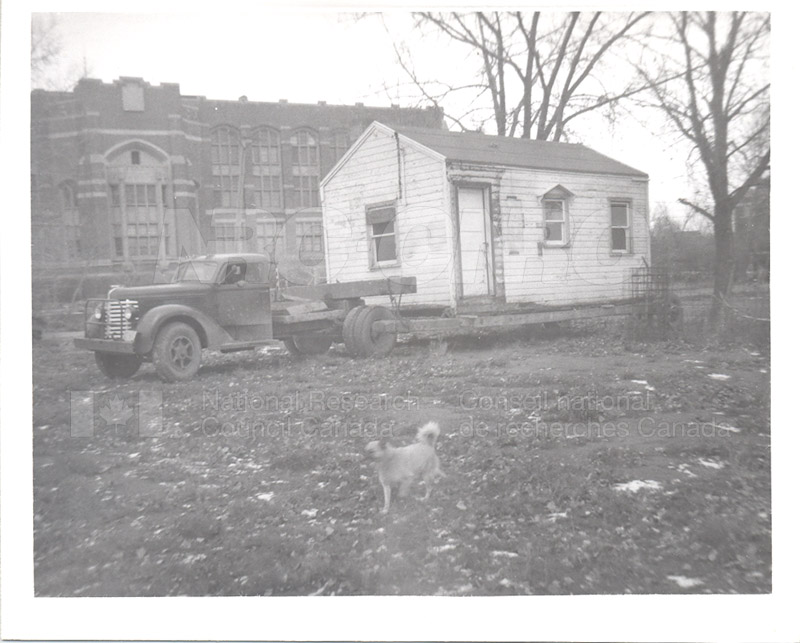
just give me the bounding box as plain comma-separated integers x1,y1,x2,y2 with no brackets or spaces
458,188,494,297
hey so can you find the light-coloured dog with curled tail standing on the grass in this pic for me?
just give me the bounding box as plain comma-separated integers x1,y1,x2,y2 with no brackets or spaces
367,422,444,514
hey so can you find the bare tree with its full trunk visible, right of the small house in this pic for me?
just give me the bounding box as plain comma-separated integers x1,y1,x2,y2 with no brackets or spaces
639,11,770,324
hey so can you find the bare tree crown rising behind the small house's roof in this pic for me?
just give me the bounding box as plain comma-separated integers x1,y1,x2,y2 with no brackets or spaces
398,12,648,141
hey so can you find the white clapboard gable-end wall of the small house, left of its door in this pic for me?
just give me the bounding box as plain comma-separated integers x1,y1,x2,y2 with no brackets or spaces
323,130,453,305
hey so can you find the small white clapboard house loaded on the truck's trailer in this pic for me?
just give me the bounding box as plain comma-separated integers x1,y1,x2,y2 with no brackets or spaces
322,122,650,311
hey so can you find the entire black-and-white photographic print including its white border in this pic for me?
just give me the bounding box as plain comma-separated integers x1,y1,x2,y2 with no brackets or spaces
0,2,797,640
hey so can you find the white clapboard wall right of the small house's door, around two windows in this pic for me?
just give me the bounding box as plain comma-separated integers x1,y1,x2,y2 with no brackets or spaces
498,169,650,304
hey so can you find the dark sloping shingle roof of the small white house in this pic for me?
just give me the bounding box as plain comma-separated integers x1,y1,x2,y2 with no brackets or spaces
395,127,647,178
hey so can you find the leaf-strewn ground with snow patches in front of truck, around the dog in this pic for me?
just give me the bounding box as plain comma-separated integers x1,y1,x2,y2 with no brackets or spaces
33,325,771,596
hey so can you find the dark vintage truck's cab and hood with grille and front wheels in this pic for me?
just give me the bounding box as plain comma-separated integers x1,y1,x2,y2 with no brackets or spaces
75,254,273,381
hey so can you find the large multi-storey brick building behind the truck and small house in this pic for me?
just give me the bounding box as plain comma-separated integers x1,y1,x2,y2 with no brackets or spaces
31,78,443,286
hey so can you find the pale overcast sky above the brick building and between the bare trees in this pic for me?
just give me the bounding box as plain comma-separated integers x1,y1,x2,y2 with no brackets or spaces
37,9,690,217
